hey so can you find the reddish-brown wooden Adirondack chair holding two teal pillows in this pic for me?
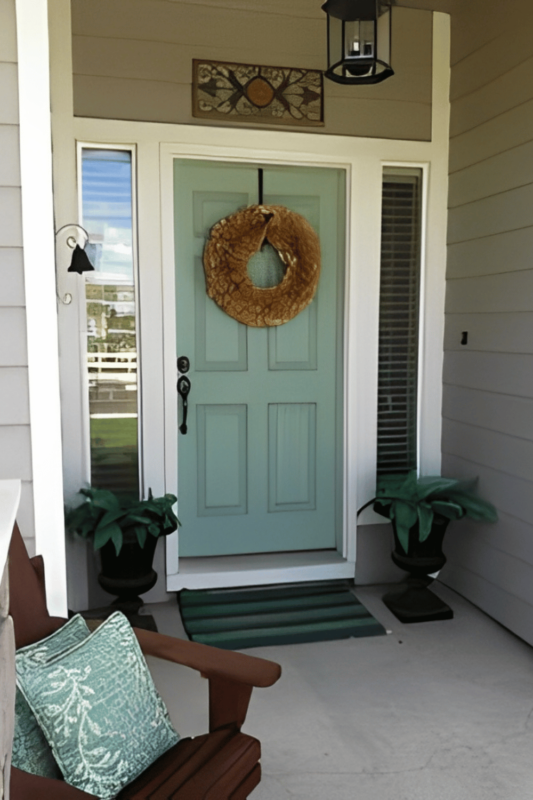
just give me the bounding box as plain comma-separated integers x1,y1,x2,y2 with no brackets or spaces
9,525,281,800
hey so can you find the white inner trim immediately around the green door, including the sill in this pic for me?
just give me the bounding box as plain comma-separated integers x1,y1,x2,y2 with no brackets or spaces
161,145,356,591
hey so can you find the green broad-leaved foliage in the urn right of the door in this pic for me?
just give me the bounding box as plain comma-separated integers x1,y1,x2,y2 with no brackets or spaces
374,472,498,553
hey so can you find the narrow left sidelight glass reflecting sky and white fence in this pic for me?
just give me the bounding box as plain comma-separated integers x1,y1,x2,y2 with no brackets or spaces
82,148,139,496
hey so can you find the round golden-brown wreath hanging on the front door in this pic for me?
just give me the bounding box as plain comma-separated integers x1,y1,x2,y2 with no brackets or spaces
204,205,320,328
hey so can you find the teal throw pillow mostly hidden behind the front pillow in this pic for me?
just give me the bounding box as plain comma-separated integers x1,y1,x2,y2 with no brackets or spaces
11,614,90,778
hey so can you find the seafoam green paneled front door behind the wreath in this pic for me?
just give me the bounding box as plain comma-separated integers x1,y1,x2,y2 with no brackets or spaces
174,159,345,558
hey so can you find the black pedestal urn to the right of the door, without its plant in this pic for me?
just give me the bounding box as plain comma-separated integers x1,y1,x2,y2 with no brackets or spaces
383,514,453,623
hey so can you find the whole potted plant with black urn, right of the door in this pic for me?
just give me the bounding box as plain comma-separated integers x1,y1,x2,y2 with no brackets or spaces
371,471,498,622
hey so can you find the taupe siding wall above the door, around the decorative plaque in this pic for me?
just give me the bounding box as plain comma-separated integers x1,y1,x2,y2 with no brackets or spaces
72,0,433,141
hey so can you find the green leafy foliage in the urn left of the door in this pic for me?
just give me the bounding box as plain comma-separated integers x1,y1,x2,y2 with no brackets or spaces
65,487,181,556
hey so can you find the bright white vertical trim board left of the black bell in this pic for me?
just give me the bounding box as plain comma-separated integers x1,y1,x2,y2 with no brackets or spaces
16,0,67,616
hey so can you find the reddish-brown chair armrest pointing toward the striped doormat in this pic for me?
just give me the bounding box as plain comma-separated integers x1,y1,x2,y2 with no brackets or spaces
133,628,281,687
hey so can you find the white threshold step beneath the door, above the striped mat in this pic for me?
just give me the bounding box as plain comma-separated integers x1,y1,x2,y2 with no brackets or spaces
167,550,355,592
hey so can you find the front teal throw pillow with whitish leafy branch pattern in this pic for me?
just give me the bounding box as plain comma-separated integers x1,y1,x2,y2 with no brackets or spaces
17,612,179,800
